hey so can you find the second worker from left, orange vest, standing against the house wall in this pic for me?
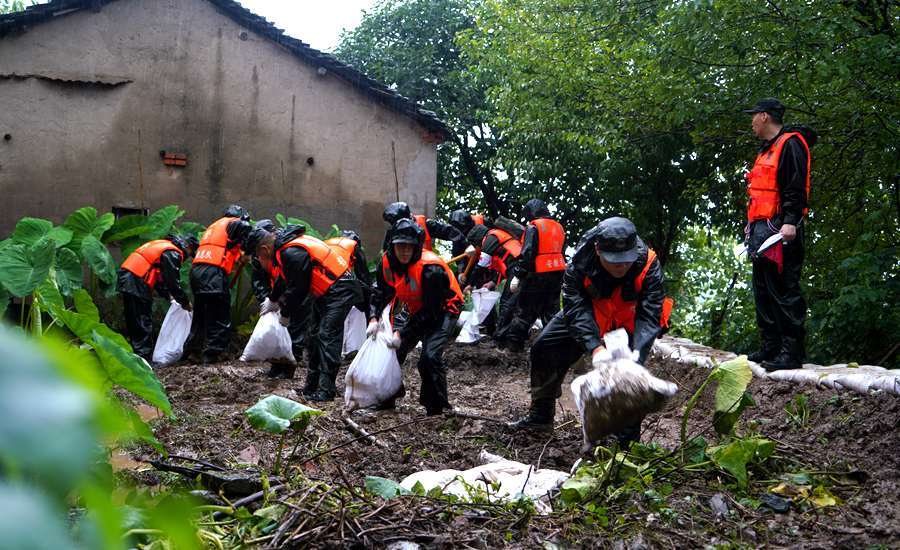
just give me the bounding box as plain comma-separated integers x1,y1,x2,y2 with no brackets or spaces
185,204,252,363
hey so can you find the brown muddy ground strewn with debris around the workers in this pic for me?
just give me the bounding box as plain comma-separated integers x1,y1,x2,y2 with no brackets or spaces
128,343,900,549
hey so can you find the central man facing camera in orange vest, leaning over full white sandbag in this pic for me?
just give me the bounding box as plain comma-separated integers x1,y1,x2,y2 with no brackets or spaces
366,218,463,416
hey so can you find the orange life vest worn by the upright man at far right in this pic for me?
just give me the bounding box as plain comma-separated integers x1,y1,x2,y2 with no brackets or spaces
747,132,812,222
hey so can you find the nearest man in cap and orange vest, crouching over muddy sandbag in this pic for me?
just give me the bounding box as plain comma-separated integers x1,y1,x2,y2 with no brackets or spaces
510,217,672,441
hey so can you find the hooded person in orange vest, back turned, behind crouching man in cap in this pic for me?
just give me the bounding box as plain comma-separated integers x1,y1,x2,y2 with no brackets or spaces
506,199,566,351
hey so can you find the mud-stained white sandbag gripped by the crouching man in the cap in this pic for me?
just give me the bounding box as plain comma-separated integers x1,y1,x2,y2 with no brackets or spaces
572,329,678,450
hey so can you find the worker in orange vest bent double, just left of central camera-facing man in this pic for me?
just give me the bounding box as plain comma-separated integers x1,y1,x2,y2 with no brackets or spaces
255,227,363,401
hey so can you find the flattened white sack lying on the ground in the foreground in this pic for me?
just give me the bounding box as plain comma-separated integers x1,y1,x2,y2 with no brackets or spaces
400,451,569,514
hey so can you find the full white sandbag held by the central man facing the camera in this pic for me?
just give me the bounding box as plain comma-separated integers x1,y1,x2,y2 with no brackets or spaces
344,305,403,412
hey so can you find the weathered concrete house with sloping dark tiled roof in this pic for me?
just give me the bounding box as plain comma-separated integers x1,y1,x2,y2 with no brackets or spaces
0,0,449,250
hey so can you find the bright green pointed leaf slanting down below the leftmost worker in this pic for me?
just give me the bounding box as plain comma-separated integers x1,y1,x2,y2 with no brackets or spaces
90,329,174,418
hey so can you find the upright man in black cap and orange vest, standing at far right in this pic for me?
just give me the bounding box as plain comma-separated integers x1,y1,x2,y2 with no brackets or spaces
744,98,817,371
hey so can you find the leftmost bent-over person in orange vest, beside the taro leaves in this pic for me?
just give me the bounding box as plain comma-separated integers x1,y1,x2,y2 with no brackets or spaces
116,235,198,363
